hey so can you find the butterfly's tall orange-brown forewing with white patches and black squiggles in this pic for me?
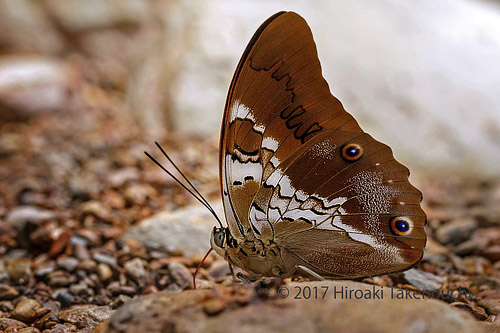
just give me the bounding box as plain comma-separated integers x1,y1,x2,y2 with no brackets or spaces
220,13,360,235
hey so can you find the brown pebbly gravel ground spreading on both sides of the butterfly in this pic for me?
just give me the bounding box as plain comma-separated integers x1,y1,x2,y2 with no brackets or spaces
0,84,500,332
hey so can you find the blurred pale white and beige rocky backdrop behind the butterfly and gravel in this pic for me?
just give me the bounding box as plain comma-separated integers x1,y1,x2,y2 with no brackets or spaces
0,0,500,177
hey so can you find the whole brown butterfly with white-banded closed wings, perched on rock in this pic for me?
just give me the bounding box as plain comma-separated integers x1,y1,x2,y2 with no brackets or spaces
147,12,426,286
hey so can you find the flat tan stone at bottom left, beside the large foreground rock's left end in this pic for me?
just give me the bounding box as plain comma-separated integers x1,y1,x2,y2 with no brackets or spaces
59,305,113,329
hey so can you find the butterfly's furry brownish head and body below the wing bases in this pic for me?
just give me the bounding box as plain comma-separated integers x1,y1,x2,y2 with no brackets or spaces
210,228,285,276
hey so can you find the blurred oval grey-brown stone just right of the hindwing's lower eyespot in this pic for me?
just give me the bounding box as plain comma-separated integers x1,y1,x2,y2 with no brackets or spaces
435,217,479,245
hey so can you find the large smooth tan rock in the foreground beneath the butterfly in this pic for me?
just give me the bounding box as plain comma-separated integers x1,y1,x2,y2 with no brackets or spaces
95,281,493,333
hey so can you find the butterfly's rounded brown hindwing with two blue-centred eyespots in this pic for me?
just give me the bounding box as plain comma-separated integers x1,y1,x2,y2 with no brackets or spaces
250,130,426,277
